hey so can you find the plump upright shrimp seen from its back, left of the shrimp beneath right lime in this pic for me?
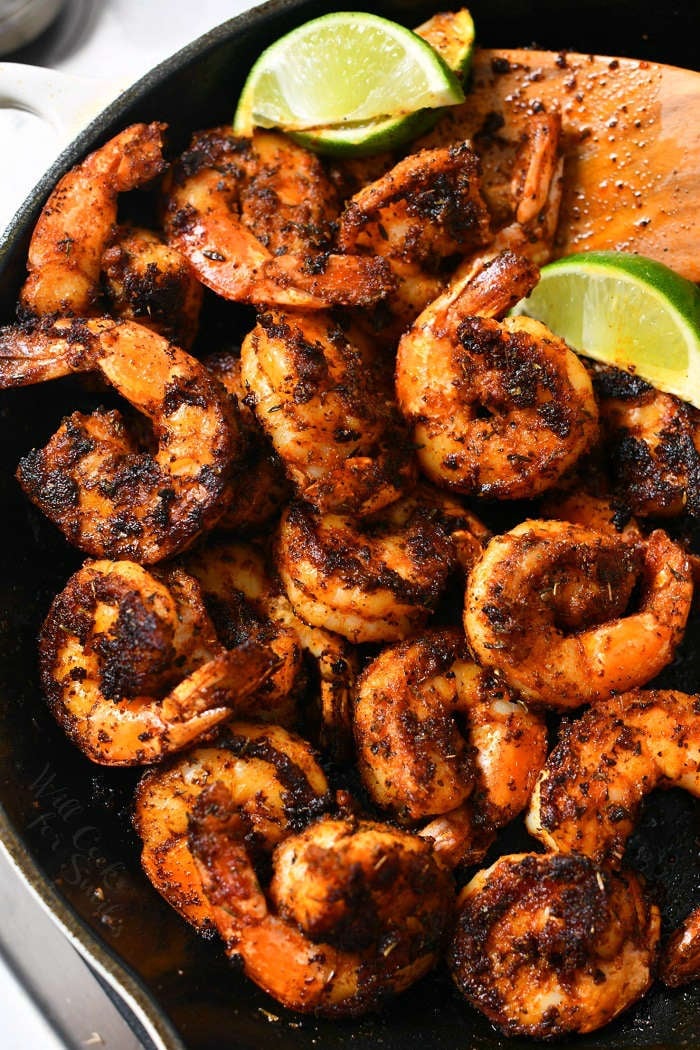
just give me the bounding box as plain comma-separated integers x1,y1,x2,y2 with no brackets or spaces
240,311,416,515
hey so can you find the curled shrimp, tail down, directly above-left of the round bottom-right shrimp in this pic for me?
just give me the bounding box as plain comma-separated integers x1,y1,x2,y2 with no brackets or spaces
354,629,547,866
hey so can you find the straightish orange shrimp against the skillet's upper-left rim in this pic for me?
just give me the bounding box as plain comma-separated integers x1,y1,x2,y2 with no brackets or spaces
20,123,166,317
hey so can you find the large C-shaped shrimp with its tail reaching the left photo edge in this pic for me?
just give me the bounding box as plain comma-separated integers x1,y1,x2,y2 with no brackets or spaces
0,318,241,564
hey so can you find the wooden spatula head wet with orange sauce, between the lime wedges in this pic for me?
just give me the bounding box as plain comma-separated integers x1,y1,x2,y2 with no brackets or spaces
421,49,700,281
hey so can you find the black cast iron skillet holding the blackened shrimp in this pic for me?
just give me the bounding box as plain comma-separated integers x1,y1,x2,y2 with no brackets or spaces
0,0,700,1050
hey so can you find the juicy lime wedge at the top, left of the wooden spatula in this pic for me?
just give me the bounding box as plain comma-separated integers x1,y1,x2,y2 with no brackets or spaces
233,12,464,151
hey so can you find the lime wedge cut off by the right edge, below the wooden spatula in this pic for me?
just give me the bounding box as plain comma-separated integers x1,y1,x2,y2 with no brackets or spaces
511,251,700,407
